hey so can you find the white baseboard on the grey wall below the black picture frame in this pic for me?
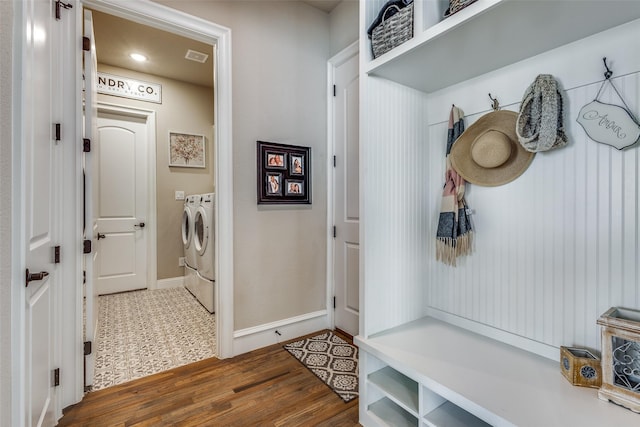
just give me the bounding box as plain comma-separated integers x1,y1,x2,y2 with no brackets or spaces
233,310,329,356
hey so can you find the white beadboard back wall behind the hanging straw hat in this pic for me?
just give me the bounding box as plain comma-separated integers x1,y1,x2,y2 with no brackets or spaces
428,73,640,356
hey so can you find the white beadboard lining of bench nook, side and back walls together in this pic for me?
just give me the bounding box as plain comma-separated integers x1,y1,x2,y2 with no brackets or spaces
361,14,640,357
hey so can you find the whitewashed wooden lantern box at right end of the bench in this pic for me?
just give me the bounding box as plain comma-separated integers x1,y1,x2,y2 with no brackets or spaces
598,307,640,414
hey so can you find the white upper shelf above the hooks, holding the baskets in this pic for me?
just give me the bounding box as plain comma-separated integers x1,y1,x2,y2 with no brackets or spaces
365,0,640,93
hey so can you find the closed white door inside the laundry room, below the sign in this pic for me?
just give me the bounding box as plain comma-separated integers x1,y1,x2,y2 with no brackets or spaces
94,112,149,295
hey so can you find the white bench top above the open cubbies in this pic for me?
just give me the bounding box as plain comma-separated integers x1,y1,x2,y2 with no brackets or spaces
355,317,640,426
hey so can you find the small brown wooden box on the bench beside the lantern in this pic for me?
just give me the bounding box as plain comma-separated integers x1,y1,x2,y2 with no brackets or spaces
560,347,602,388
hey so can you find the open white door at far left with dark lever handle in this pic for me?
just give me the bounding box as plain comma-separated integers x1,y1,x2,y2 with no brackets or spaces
23,0,61,426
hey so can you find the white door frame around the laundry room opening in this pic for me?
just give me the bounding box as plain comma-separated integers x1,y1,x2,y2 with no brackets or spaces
69,0,234,407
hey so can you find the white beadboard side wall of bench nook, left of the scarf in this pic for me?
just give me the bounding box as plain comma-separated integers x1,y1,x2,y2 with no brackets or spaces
360,78,433,336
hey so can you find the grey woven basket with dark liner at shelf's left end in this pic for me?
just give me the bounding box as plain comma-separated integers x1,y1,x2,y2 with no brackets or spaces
371,3,413,58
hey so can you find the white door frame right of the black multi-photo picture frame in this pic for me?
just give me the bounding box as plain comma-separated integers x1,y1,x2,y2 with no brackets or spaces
326,41,362,329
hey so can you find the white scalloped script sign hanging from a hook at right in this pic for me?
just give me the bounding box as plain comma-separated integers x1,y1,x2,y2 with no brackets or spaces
578,100,640,150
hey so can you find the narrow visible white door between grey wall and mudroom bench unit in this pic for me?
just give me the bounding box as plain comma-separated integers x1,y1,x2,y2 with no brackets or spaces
333,49,360,335
